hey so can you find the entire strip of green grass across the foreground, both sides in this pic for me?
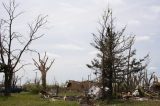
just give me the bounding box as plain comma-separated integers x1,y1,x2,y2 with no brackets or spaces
0,93,160,106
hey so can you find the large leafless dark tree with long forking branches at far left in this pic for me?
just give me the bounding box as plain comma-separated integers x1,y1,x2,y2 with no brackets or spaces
0,0,47,96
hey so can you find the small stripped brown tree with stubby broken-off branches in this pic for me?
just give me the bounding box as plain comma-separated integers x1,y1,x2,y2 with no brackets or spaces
33,52,54,90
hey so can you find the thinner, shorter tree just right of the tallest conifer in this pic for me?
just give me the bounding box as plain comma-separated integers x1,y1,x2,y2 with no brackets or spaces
125,37,149,92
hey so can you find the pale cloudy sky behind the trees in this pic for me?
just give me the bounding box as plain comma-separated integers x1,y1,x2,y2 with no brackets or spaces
0,0,160,84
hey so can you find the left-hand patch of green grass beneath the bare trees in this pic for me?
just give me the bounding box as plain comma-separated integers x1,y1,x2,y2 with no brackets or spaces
0,93,78,106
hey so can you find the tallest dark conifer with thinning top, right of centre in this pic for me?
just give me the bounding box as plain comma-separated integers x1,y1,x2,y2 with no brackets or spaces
87,9,130,99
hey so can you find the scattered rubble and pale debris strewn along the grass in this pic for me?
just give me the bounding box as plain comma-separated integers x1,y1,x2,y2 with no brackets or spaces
40,85,159,106
